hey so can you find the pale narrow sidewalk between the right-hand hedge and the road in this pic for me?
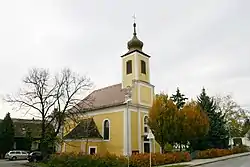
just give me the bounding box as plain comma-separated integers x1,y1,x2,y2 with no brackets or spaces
160,152,250,167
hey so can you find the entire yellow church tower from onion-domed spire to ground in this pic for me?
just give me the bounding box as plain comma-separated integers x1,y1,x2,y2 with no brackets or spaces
121,19,155,155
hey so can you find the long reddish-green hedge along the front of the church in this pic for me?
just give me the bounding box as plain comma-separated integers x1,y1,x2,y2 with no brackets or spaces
47,152,191,167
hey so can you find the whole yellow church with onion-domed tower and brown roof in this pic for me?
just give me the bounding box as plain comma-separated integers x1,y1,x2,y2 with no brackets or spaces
62,23,161,155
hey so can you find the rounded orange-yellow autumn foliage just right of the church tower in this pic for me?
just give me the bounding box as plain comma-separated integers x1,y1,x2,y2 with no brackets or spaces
149,93,209,151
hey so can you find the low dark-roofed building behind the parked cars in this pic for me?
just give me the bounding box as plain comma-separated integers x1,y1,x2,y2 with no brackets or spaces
0,118,41,151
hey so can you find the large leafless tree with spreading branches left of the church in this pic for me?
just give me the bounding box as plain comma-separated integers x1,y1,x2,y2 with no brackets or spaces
5,68,93,154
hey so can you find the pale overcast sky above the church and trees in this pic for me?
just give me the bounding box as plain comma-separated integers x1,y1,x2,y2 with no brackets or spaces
0,0,250,118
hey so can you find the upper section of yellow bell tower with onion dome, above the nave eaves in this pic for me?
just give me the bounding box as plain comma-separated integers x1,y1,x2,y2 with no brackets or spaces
121,22,154,107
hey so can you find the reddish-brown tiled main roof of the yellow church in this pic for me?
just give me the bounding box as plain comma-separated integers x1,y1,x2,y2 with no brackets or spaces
78,83,125,110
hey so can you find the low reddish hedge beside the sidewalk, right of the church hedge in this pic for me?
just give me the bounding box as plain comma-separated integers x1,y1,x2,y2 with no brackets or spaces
196,146,248,159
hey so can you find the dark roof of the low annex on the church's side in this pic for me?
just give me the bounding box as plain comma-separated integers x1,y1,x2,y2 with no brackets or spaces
64,118,102,139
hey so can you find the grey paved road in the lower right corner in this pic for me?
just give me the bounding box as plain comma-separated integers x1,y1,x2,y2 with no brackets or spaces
199,156,250,167
